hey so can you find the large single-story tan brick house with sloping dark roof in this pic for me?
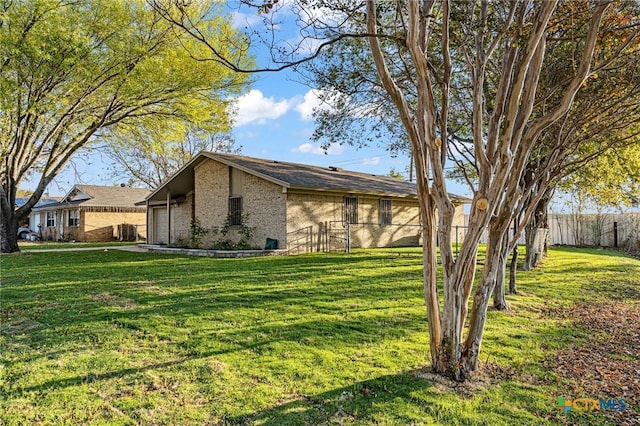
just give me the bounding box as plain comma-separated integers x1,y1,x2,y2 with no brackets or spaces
146,152,468,253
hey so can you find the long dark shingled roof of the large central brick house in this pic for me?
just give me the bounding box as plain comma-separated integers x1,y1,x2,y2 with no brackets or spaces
147,152,471,204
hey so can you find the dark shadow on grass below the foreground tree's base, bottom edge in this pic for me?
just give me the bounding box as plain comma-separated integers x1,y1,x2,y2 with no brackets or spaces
224,371,538,426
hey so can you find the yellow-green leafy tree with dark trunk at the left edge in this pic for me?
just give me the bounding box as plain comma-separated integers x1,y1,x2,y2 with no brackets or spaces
0,0,251,252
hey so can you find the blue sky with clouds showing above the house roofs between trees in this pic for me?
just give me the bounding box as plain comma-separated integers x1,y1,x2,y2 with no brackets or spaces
22,2,468,199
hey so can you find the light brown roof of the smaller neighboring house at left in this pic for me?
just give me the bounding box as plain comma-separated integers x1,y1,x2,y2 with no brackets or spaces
34,185,151,210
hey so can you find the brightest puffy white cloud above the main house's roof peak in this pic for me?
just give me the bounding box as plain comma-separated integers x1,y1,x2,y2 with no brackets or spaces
235,90,294,127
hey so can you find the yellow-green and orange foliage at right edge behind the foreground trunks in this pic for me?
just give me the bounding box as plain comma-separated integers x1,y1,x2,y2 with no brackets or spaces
494,2,640,308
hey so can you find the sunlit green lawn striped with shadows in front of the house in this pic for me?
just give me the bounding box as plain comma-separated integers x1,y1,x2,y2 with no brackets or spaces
0,248,640,425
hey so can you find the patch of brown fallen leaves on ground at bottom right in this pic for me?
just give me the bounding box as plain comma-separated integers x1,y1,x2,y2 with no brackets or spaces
544,302,640,425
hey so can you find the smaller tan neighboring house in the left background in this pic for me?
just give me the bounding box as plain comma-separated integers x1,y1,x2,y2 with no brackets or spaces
30,185,151,241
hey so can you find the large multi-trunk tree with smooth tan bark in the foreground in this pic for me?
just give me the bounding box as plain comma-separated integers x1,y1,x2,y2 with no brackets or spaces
159,0,636,380
